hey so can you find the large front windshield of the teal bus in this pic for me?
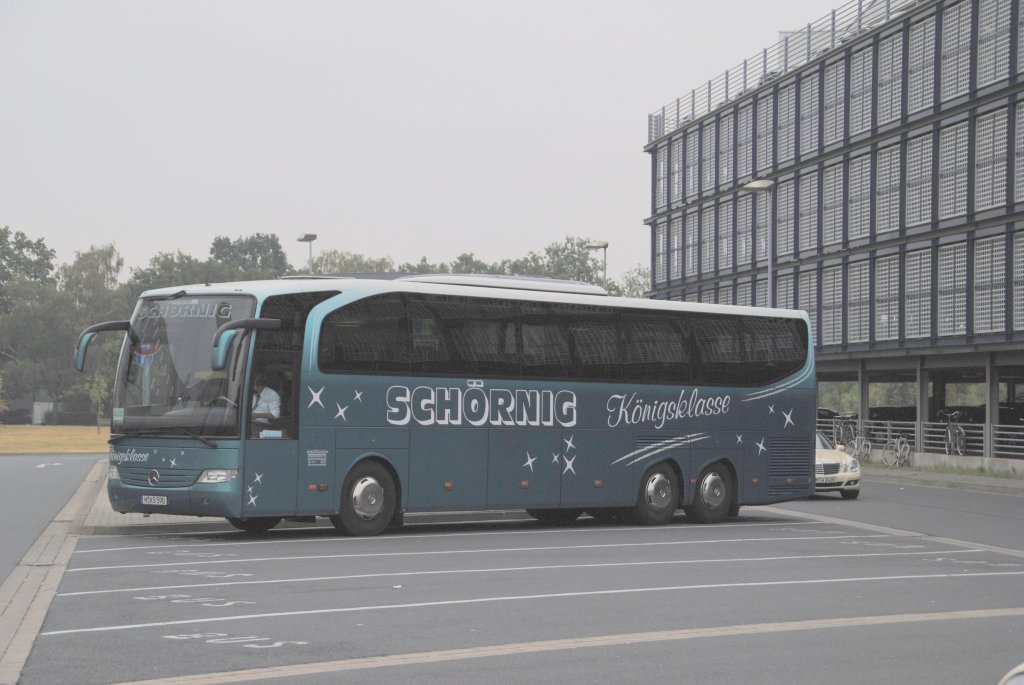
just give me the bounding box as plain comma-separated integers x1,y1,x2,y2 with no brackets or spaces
112,292,255,437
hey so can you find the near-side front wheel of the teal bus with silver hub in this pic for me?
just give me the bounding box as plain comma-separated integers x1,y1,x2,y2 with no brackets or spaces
331,461,398,537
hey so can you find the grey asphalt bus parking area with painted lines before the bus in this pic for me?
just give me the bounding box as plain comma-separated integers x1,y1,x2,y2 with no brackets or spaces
2,458,1024,685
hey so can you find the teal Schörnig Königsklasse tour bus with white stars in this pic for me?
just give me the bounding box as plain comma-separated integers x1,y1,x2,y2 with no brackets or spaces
75,274,816,536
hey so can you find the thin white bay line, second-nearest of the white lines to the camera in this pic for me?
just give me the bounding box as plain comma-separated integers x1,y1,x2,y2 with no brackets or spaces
57,550,983,597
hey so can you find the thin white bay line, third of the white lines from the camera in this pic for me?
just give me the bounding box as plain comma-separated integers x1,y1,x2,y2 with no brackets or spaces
67,534,889,573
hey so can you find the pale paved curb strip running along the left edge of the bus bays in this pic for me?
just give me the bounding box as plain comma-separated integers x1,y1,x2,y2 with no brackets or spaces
0,460,106,685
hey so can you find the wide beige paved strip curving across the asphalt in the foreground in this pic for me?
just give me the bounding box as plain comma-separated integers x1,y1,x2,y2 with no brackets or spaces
105,607,1024,685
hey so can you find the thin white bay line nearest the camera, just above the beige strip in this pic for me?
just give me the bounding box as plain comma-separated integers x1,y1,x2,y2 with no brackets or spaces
39,570,1024,637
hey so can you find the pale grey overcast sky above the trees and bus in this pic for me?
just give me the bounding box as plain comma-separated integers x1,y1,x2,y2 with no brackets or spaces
0,0,839,277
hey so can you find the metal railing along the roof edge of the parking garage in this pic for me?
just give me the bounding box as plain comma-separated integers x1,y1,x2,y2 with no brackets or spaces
647,0,931,142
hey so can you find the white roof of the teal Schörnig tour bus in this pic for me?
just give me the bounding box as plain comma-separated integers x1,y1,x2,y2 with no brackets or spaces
141,273,810,322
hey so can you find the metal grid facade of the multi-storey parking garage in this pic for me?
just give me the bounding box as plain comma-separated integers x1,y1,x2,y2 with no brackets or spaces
647,0,1024,360
